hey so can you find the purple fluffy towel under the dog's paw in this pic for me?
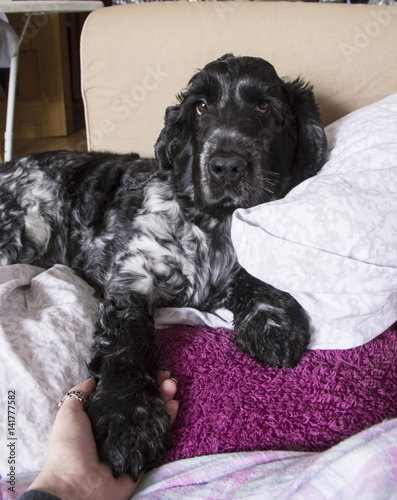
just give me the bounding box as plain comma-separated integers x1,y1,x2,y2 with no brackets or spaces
157,326,397,462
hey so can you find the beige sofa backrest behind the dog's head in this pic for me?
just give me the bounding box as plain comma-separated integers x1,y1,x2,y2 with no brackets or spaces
81,1,397,156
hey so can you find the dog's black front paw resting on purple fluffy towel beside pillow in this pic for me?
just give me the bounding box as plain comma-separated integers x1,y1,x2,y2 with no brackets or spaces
234,292,310,367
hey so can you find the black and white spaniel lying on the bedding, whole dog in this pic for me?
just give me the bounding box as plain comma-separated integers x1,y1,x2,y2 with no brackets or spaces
0,55,327,480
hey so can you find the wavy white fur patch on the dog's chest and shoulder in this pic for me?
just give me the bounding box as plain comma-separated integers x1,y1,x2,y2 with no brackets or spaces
116,181,235,307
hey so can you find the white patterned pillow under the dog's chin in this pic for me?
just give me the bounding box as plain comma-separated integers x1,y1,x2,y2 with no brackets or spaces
232,94,397,349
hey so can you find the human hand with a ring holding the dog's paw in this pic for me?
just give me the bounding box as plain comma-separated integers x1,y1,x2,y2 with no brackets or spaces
29,371,178,500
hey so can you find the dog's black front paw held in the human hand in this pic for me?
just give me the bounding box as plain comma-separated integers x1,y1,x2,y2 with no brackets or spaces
85,380,170,481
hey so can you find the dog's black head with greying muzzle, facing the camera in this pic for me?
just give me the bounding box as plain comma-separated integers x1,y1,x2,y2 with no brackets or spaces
156,54,327,216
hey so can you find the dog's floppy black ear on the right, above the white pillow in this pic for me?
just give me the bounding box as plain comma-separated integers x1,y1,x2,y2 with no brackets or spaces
285,78,327,185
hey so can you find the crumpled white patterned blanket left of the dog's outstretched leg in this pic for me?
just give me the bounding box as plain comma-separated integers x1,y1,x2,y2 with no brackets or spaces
0,265,98,477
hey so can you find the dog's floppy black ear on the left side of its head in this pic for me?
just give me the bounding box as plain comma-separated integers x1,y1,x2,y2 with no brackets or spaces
155,105,183,170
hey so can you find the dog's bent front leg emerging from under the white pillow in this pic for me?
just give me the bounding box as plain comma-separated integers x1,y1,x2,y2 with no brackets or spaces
234,269,310,367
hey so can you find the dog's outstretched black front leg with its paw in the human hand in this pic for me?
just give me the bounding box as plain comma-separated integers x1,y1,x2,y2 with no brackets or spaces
85,286,170,481
